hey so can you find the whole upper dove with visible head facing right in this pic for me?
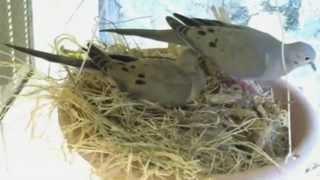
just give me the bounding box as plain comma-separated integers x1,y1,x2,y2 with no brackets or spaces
100,13,316,81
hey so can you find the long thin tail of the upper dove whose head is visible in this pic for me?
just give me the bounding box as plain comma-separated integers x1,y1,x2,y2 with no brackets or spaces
100,29,183,44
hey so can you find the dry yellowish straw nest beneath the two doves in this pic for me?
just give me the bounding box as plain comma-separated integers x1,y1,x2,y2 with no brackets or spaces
33,40,288,179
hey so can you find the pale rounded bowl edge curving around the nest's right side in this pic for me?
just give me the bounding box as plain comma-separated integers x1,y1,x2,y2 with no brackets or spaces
215,80,320,180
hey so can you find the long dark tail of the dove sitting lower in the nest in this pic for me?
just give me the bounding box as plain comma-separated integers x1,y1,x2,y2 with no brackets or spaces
5,44,97,69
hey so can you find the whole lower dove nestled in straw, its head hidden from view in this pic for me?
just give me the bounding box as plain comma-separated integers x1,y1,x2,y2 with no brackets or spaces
7,44,205,106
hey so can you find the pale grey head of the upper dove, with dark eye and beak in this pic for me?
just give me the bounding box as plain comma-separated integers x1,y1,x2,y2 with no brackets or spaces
285,42,316,70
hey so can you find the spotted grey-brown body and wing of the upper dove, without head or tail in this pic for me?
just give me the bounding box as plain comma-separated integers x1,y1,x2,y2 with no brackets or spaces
166,14,280,79
